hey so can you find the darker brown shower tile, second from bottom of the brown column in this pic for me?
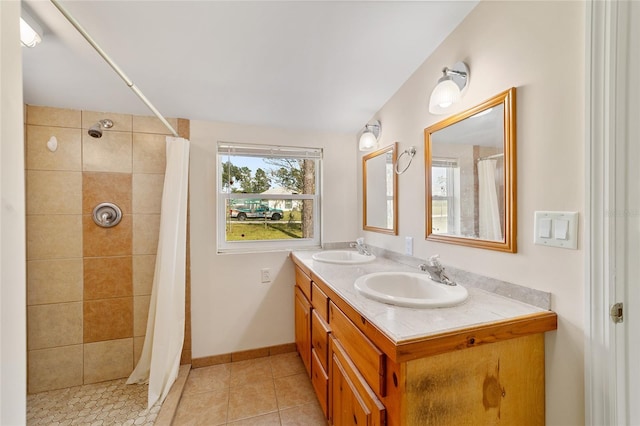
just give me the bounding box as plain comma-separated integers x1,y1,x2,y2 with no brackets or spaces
83,256,133,300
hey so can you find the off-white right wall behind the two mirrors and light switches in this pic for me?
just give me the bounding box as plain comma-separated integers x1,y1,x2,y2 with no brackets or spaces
359,1,585,425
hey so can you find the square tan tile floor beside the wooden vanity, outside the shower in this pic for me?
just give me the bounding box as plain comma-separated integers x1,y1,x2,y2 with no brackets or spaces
173,352,327,426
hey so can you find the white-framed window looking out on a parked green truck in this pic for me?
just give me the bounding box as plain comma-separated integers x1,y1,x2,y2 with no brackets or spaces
217,142,322,252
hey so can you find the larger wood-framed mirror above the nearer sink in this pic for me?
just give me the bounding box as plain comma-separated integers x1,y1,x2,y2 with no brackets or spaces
424,88,516,253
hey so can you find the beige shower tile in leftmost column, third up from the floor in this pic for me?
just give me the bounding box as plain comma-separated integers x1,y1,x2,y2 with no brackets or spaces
27,258,82,305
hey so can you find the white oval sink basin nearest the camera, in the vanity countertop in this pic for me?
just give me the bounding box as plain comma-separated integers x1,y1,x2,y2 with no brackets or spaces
354,272,468,308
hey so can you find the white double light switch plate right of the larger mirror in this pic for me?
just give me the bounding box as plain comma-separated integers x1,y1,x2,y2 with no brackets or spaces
533,211,578,250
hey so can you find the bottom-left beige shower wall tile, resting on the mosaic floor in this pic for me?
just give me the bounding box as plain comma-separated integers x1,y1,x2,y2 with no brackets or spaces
27,345,82,393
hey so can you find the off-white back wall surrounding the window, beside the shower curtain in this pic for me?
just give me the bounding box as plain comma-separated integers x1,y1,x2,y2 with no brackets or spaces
189,121,358,358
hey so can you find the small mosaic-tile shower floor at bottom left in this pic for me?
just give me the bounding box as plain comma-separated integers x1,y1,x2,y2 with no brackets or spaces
27,379,160,426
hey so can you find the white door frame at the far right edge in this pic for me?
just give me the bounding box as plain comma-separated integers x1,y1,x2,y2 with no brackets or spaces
585,0,629,425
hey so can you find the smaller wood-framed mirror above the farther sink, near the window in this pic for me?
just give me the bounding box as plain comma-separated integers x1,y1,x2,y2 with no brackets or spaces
362,142,398,235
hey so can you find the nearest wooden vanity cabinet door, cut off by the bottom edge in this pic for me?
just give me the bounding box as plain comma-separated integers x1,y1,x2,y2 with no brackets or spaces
329,339,386,426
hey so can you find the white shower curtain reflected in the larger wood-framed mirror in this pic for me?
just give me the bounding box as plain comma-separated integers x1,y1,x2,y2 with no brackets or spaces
478,159,503,241
